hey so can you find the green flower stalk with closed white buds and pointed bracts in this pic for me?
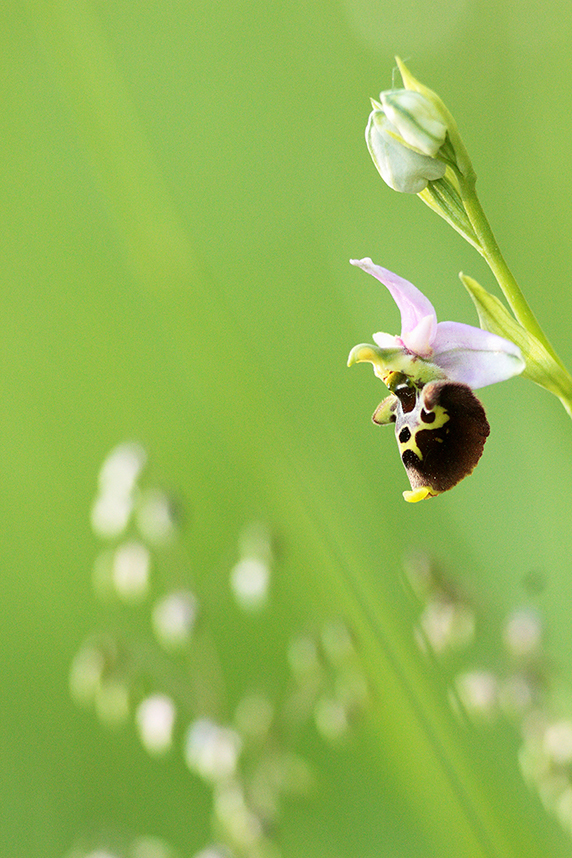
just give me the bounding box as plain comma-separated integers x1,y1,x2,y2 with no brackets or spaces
366,57,572,417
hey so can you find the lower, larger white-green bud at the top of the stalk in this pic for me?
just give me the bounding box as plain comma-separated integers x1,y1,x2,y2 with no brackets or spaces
365,102,446,194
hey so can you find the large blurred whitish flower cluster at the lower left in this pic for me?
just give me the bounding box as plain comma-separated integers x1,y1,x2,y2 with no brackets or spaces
70,443,374,858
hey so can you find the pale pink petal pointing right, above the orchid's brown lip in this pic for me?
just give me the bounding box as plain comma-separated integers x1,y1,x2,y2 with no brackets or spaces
432,322,525,389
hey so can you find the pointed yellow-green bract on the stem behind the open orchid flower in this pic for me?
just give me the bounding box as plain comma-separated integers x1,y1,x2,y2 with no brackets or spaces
459,273,570,398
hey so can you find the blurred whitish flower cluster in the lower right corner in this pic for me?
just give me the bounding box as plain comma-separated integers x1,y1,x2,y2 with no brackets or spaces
404,552,572,835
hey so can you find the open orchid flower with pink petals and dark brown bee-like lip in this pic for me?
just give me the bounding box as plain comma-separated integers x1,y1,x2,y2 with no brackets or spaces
348,259,525,503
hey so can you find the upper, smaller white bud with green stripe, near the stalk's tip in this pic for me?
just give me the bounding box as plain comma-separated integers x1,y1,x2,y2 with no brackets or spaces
380,89,447,158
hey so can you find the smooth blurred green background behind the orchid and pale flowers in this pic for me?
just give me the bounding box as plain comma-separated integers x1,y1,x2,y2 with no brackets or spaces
0,0,572,858
